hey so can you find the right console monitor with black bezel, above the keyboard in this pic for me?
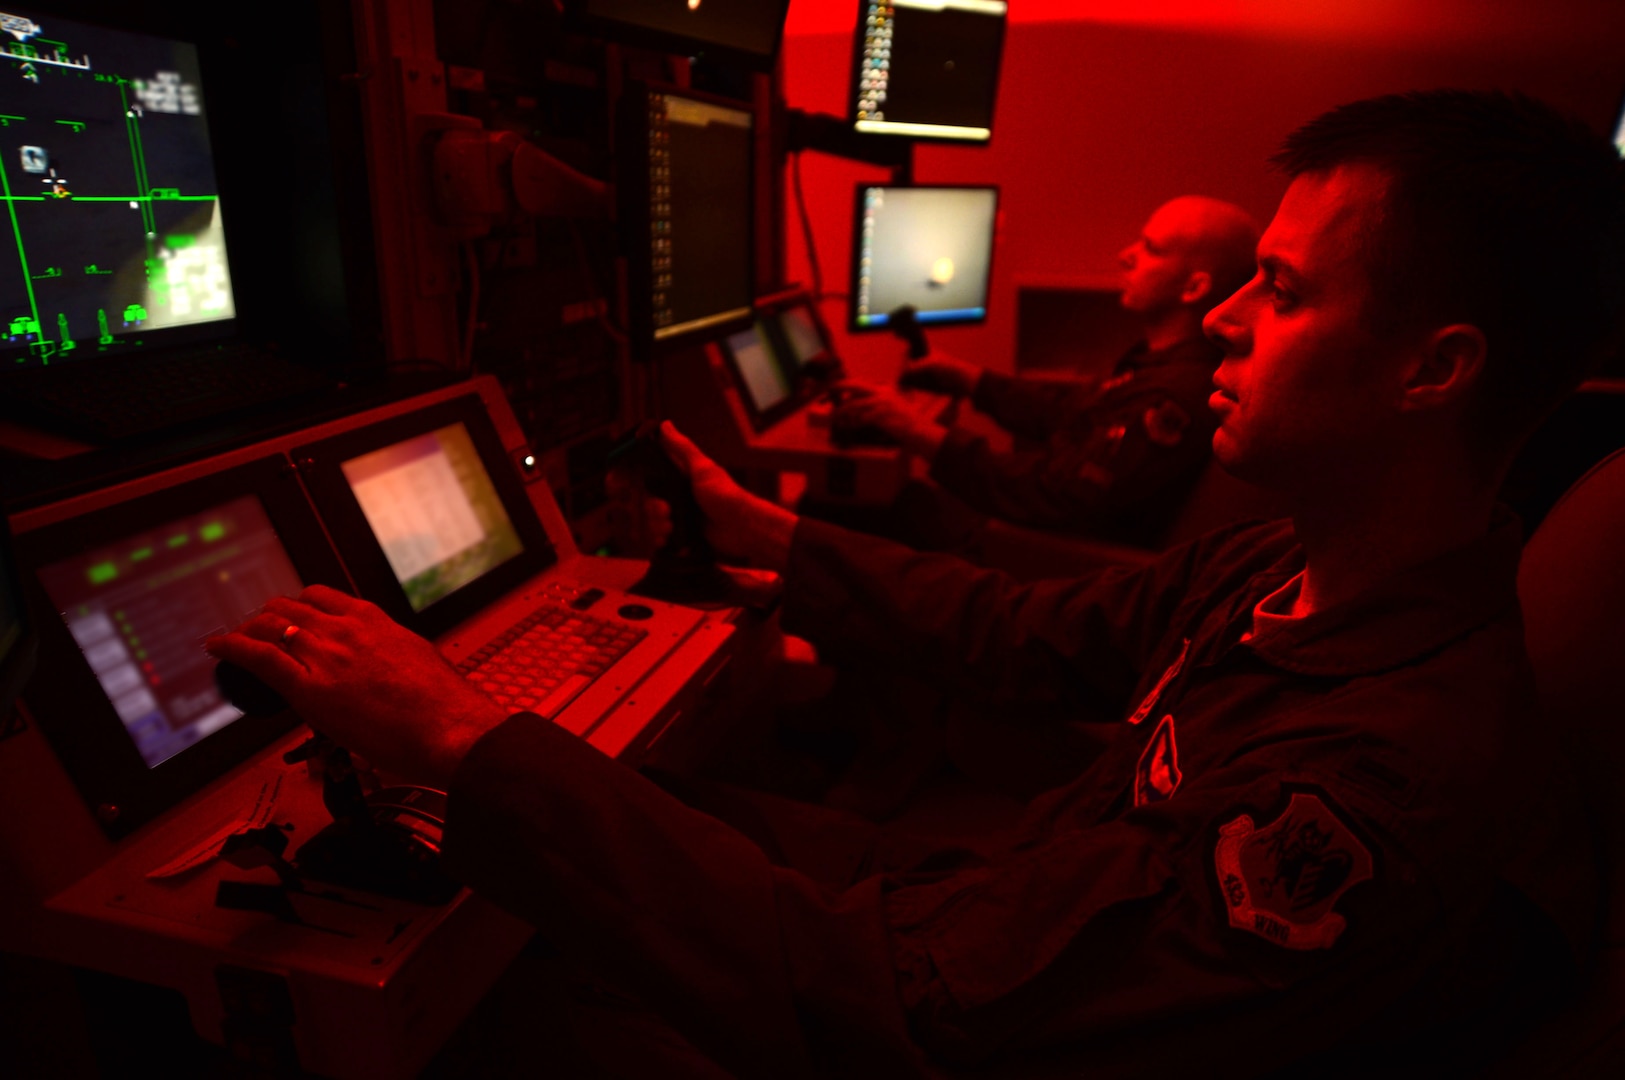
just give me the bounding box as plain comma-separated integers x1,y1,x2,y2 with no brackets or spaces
284,395,556,637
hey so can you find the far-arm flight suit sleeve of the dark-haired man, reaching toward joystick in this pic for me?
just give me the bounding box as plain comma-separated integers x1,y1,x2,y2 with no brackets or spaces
782,520,1240,706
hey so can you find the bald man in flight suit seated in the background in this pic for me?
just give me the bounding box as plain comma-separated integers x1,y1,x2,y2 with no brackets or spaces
840,195,1259,557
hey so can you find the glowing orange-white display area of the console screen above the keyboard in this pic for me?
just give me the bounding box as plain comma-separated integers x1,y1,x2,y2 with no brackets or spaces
340,422,525,611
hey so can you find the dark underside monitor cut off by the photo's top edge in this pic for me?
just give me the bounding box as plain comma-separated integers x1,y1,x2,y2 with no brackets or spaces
569,0,790,71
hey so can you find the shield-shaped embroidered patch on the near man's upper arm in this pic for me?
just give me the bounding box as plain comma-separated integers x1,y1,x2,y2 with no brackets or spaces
1214,791,1373,950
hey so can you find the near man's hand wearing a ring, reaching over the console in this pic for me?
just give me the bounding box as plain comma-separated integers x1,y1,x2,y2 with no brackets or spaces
205,585,507,788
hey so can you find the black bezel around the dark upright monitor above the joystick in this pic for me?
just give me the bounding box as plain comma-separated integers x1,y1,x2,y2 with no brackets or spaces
616,81,762,361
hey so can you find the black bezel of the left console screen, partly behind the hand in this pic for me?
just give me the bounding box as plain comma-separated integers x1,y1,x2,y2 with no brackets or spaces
16,455,349,840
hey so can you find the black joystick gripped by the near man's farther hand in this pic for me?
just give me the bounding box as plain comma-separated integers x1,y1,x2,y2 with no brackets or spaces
609,421,731,604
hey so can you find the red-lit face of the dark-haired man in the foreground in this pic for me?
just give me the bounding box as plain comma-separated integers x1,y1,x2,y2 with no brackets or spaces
1203,166,1402,494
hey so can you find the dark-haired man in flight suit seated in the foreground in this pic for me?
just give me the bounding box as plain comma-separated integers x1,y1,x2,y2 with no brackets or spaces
210,91,1625,1077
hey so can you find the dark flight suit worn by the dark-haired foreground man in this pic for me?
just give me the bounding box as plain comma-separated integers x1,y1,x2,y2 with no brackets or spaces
445,518,1596,1077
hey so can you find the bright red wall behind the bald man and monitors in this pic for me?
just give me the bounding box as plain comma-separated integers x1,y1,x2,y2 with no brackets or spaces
783,15,1625,378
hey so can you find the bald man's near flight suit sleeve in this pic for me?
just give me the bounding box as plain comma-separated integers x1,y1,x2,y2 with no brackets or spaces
931,383,1212,529
